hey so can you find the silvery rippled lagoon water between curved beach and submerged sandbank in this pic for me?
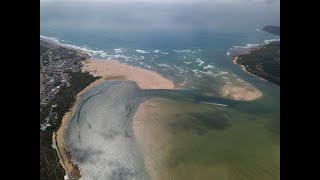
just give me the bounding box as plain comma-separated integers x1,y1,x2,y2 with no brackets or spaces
64,81,148,180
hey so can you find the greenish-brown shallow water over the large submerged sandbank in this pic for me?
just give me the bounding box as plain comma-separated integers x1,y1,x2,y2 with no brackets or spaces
136,99,280,179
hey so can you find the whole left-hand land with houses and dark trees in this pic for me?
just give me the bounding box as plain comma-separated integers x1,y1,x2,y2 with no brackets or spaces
40,38,99,180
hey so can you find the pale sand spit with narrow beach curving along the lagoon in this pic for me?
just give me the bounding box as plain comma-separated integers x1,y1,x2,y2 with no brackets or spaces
52,60,175,179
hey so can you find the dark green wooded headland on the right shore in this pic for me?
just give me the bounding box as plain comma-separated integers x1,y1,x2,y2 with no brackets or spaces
237,42,280,86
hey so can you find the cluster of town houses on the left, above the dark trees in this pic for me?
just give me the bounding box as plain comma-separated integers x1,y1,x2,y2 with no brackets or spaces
40,40,89,130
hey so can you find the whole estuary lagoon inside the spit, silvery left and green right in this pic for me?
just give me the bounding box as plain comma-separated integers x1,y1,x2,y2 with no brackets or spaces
64,80,280,179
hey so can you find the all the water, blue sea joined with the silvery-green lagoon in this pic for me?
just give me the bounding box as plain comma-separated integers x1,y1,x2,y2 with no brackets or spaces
40,2,280,180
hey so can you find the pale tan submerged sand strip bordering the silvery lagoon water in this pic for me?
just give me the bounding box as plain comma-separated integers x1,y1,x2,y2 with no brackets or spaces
133,100,171,180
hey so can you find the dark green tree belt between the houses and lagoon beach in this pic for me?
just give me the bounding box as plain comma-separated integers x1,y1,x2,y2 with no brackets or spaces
40,72,98,180
